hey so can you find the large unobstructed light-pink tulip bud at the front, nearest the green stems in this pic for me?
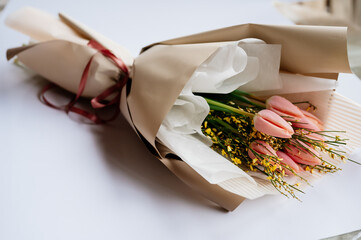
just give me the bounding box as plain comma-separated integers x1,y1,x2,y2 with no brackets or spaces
253,109,294,138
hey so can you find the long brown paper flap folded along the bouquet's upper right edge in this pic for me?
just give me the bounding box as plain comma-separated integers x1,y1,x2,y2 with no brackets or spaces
141,23,351,74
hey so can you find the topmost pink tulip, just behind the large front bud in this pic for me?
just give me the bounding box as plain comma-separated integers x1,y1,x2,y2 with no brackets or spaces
266,96,303,121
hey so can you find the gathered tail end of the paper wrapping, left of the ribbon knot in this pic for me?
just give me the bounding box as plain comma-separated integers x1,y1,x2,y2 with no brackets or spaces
5,7,133,97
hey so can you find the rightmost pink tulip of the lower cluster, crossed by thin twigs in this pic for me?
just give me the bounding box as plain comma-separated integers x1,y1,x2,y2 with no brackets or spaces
285,141,321,166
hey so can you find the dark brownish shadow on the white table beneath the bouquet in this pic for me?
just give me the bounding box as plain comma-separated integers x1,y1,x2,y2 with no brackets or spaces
93,116,224,211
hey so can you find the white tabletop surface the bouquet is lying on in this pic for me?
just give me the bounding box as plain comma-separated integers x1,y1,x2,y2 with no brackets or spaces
0,0,361,240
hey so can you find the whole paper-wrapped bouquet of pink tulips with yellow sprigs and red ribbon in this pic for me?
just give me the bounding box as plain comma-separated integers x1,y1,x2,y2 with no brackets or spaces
7,8,361,210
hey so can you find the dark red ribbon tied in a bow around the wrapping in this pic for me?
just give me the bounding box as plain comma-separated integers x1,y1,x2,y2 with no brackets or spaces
40,40,129,124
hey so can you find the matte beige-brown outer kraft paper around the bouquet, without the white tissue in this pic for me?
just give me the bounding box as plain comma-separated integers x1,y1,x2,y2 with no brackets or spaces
8,9,361,210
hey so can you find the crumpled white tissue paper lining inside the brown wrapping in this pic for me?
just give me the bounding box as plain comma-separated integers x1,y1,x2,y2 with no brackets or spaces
157,39,282,185
